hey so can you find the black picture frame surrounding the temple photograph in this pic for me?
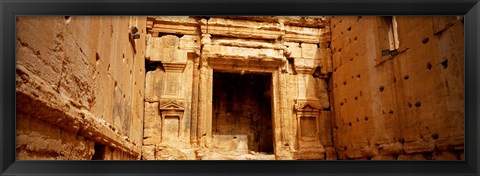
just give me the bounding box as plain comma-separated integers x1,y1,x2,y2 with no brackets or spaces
0,0,480,176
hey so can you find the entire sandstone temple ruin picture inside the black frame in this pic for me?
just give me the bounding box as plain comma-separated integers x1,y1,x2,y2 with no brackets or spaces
16,16,464,160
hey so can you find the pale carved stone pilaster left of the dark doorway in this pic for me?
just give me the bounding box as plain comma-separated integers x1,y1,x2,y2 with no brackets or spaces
148,35,192,141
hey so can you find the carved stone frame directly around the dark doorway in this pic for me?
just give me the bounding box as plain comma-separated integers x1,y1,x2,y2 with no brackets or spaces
194,34,287,155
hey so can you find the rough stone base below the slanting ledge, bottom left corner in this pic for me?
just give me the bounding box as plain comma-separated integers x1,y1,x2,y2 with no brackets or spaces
16,112,94,160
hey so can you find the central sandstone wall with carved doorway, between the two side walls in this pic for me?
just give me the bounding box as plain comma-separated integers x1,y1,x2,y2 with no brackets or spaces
142,16,336,160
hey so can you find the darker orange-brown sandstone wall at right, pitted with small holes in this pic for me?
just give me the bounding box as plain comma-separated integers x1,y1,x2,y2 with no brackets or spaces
330,16,464,160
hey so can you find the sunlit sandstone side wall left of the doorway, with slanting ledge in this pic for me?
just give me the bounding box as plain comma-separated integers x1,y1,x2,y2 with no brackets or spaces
16,16,146,160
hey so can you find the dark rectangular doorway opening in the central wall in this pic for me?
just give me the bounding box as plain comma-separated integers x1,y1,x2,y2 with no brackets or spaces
212,71,273,153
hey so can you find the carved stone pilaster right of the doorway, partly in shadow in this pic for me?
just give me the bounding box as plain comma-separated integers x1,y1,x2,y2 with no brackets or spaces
294,43,325,159
